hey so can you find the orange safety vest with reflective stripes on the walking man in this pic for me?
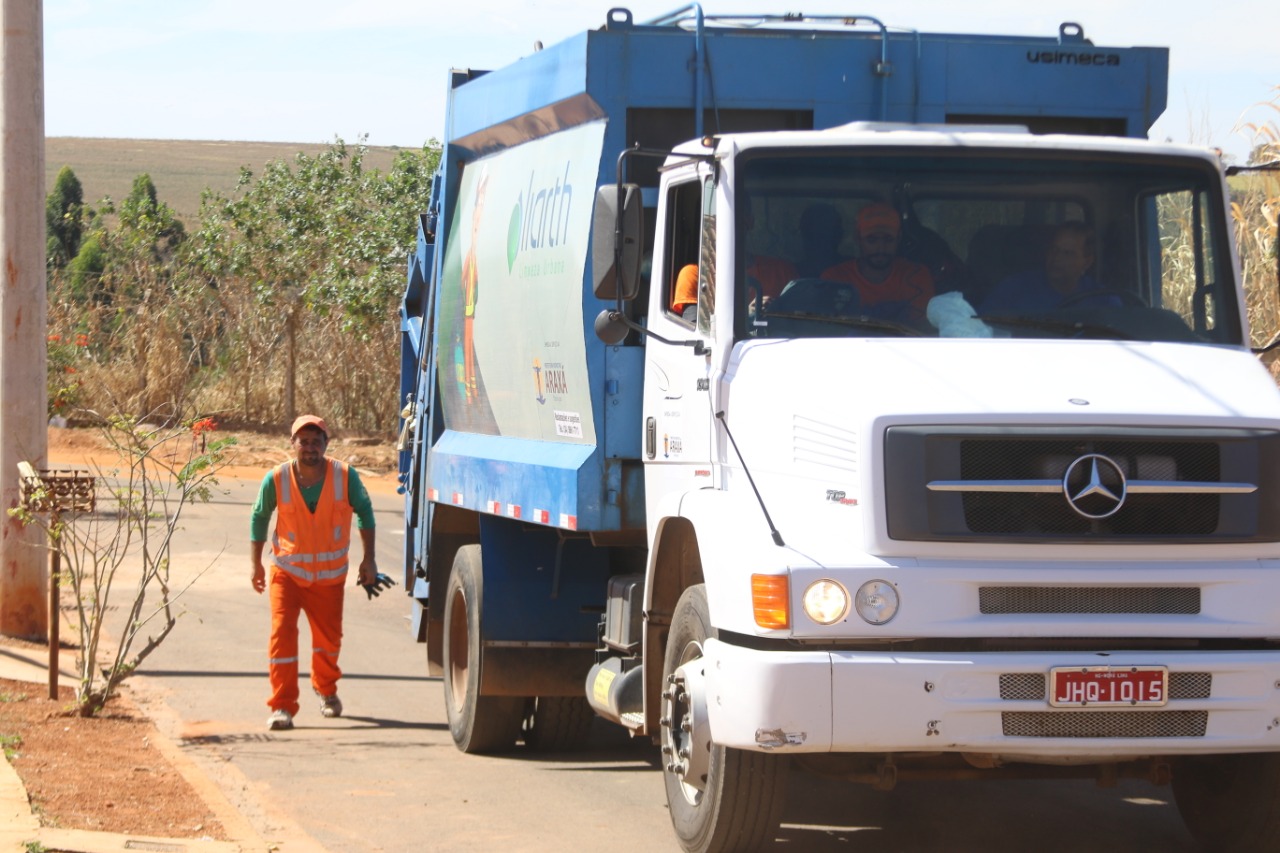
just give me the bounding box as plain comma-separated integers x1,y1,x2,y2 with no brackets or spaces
271,459,352,587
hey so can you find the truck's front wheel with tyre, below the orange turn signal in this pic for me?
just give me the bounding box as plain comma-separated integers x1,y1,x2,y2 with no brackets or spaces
662,584,788,853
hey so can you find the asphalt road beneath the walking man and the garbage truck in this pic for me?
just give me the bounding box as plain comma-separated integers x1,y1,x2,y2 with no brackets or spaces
122,471,1196,853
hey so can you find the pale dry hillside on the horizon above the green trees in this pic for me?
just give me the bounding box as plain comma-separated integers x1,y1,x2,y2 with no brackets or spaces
45,137,412,225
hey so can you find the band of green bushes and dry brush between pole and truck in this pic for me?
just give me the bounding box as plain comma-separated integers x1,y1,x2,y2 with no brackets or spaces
49,140,439,432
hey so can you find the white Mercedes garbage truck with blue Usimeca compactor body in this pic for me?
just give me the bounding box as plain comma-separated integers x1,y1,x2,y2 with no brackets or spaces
399,5,1280,850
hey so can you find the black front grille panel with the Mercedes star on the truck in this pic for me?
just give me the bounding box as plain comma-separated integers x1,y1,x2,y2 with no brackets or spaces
884,427,1280,537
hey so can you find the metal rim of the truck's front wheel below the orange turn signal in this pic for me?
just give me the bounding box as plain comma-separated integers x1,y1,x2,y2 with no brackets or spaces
662,642,712,806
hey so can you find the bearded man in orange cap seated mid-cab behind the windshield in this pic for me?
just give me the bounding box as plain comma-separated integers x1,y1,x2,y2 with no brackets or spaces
822,201,934,323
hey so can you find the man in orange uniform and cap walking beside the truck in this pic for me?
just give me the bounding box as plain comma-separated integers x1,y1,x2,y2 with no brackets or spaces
250,415,379,730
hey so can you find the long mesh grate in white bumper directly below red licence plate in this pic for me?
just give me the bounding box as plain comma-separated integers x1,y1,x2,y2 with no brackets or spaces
1000,711,1208,738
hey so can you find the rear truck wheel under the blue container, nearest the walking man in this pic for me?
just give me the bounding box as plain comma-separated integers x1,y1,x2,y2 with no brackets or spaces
444,544,525,753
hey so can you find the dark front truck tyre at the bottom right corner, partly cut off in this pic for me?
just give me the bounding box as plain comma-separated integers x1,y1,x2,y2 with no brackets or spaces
1172,753,1280,853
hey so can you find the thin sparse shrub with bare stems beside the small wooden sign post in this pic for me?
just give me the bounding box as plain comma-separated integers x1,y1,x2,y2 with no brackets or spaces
9,415,236,716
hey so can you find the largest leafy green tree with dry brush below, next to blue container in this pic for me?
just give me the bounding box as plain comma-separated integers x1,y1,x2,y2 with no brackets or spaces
189,140,439,429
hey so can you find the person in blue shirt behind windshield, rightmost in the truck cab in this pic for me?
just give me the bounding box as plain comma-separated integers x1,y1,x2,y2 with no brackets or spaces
978,222,1120,315
